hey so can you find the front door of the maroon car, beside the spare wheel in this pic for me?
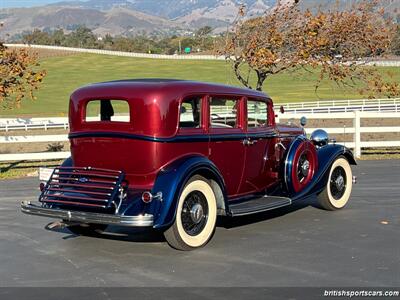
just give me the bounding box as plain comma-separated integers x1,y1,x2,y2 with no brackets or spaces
239,98,276,194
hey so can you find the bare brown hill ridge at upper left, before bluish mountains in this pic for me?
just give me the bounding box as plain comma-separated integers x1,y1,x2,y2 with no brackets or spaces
0,5,183,36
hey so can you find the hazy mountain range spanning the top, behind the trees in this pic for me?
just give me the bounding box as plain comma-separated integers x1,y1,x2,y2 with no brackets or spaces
0,0,400,38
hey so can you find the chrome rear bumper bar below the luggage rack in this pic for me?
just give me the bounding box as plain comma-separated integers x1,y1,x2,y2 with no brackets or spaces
21,201,153,227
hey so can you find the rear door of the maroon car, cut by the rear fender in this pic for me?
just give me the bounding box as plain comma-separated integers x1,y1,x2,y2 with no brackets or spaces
208,95,246,198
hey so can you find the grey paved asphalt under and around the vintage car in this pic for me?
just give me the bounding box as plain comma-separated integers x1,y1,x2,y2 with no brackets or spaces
0,160,400,287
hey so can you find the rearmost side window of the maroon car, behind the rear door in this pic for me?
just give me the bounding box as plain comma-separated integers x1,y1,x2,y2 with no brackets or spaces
179,96,202,128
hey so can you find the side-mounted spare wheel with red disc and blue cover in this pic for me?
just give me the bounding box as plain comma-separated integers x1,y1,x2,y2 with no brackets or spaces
284,136,318,195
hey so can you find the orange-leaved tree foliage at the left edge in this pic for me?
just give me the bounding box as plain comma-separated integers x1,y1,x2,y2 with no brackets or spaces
0,23,46,110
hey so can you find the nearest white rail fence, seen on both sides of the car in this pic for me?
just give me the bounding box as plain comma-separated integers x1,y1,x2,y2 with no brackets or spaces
0,111,400,161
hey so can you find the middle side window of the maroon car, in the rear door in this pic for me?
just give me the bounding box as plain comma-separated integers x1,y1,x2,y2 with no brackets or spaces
210,97,239,128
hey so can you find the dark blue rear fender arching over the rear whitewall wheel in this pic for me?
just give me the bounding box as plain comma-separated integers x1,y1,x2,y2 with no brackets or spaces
145,155,226,228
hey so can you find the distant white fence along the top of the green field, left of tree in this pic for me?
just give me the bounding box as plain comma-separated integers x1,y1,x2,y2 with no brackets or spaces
5,44,225,60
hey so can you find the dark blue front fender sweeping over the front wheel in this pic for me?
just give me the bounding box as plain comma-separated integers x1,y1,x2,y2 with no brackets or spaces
292,144,357,201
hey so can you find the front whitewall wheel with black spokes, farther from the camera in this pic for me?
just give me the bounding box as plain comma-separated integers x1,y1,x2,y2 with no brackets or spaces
318,157,353,211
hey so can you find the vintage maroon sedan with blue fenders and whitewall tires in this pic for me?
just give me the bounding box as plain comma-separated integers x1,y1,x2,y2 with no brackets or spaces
22,79,355,250
